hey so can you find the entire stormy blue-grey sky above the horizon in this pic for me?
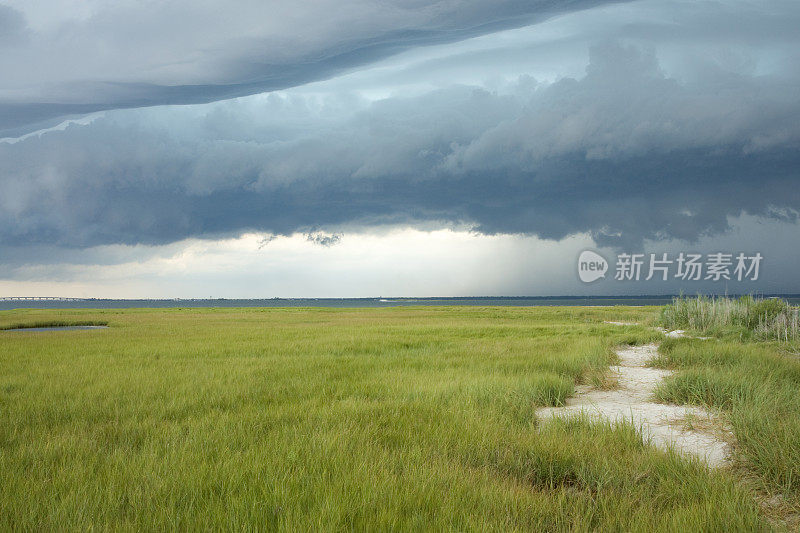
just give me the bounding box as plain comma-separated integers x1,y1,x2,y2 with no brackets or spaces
0,0,800,298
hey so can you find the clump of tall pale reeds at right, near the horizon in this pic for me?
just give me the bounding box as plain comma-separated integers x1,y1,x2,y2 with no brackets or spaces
661,295,800,342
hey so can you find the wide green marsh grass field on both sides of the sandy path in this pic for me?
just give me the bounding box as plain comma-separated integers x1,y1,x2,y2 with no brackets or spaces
0,307,800,531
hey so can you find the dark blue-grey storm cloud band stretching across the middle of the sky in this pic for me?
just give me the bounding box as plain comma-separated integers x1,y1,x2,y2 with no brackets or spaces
0,43,800,251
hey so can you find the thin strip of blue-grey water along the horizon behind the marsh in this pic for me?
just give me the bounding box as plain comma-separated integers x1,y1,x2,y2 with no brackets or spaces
0,294,800,310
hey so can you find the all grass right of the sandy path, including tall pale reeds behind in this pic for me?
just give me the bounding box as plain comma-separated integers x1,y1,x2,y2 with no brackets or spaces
654,296,800,531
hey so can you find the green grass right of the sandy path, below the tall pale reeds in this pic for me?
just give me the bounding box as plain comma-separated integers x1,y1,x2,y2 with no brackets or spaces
654,335,800,527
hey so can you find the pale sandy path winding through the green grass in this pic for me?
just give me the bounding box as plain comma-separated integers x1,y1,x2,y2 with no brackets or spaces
536,332,730,466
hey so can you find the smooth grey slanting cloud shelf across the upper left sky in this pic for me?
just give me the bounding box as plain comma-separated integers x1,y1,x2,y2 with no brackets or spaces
0,0,620,136
